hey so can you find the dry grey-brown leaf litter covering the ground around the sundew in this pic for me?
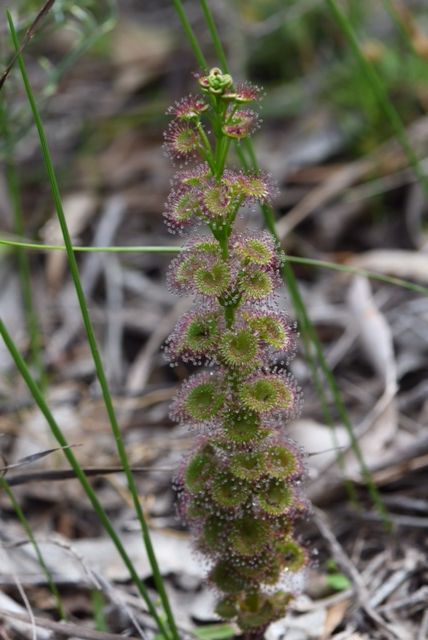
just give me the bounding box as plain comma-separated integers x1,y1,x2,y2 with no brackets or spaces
0,3,428,640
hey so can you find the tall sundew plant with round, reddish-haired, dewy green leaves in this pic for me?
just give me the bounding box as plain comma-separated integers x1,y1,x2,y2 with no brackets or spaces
165,68,308,638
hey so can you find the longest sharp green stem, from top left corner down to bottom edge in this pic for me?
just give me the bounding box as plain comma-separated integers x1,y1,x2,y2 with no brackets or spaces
7,13,179,640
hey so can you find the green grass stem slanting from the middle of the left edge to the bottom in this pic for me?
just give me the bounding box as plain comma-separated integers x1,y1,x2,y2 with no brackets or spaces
0,319,169,638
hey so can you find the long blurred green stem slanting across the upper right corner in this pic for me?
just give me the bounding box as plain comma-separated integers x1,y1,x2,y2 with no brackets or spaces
326,0,428,195
